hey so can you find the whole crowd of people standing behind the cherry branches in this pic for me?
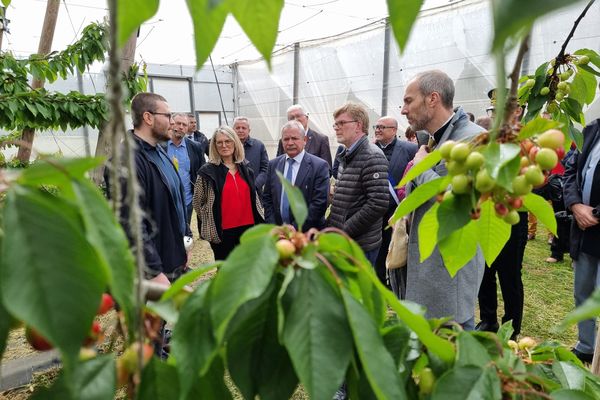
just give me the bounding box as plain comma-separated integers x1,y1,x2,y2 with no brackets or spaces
107,70,600,372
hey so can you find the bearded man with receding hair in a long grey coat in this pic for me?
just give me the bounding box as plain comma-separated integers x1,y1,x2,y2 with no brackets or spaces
402,70,485,329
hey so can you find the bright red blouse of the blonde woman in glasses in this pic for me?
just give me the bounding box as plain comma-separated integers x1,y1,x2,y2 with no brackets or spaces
221,171,254,229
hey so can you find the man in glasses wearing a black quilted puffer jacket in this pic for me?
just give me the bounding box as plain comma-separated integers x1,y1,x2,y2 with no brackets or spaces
328,103,389,264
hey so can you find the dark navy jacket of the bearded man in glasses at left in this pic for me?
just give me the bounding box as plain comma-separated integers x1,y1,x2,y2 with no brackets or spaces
105,135,189,280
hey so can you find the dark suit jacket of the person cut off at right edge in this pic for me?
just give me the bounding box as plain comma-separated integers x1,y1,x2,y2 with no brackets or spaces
563,119,600,260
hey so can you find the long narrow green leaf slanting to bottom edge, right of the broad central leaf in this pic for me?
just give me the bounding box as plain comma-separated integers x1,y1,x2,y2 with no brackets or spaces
342,287,407,399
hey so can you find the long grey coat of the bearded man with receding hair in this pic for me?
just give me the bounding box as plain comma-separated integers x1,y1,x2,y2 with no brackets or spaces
406,107,485,323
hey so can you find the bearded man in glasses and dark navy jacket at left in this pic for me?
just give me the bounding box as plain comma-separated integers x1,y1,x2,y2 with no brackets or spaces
105,92,189,285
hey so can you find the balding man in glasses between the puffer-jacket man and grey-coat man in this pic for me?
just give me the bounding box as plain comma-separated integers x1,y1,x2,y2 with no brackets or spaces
373,116,418,286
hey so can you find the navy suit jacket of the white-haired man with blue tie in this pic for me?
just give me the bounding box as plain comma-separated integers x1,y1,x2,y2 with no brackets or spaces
263,152,329,232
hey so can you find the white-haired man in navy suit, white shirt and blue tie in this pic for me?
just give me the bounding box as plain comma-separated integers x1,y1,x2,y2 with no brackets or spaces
263,121,329,232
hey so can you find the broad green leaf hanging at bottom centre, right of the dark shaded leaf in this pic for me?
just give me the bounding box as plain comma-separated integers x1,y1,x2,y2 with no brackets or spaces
283,268,352,399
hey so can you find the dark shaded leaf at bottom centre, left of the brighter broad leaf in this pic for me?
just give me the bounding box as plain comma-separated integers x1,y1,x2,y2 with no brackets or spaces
227,278,298,400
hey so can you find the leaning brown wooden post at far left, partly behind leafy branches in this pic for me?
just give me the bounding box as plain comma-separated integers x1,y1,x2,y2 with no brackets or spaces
17,0,60,164
